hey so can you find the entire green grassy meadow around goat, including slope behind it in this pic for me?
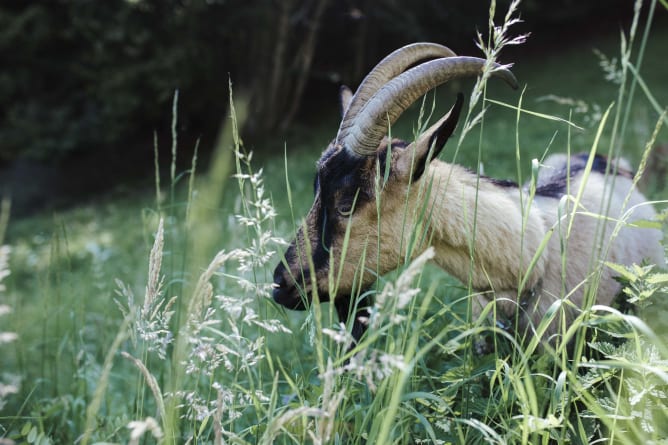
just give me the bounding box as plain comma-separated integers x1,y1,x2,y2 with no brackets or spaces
0,2,668,445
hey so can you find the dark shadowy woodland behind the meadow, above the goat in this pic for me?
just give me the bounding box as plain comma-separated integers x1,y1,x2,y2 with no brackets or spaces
0,0,665,214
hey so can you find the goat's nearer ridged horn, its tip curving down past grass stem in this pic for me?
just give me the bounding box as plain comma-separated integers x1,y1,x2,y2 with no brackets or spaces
337,57,517,156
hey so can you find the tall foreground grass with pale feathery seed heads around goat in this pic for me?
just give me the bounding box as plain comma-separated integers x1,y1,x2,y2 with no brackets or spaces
0,1,668,445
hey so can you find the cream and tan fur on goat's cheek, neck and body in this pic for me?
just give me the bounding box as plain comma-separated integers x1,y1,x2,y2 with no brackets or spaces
320,151,664,342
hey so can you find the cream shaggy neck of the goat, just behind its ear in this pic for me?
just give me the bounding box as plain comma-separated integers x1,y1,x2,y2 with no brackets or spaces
414,161,545,291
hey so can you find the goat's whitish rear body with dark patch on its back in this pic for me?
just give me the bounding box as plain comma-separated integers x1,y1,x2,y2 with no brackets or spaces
531,154,665,330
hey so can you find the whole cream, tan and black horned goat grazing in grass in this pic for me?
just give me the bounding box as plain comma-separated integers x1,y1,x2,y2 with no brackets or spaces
273,43,664,346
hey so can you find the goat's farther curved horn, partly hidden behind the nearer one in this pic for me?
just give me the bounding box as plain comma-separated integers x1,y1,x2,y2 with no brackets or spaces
341,42,456,127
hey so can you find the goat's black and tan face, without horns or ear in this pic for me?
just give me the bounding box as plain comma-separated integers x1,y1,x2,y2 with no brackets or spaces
274,135,407,309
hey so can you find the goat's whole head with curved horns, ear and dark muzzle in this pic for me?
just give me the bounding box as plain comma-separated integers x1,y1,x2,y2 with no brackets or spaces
273,43,516,332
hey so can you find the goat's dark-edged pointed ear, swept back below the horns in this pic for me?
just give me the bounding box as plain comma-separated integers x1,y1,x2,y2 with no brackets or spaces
396,93,464,181
